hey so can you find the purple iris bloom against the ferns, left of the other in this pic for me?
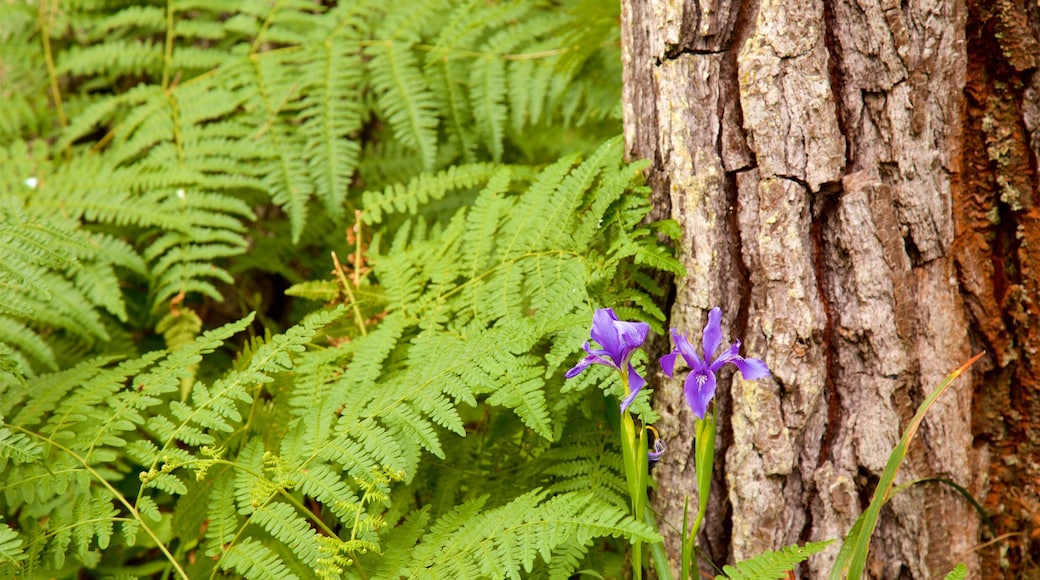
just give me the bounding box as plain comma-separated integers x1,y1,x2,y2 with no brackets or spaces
567,308,650,412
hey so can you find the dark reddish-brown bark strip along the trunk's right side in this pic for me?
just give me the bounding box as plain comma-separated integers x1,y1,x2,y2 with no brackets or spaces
954,0,1040,578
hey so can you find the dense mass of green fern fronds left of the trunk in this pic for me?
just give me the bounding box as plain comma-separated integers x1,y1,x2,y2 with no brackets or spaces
0,0,681,578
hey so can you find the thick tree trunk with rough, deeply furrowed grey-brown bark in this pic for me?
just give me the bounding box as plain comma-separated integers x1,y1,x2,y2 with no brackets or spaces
622,0,1040,578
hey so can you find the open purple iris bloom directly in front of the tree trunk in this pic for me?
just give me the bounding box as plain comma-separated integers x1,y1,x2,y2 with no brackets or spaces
660,307,770,419
